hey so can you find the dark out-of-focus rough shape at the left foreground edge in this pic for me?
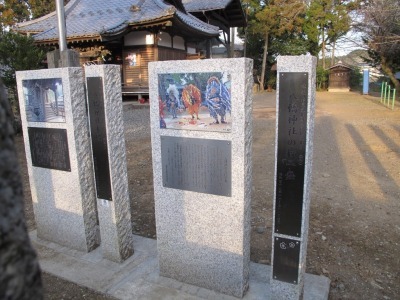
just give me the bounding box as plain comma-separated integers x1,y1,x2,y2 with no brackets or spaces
0,80,43,300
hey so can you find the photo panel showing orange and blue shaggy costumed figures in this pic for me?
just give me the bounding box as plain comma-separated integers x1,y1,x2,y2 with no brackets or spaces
158,72,232,132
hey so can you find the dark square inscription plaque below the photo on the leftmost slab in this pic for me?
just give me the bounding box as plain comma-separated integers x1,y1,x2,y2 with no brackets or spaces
28,127,71,172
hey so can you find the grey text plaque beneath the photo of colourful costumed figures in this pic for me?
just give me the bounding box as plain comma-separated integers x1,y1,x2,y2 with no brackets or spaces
161,136,232,197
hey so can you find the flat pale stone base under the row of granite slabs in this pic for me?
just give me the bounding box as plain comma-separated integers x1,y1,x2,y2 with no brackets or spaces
30,231,330,300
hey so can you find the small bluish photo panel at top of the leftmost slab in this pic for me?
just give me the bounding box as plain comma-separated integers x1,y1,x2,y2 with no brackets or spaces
22,78,65,123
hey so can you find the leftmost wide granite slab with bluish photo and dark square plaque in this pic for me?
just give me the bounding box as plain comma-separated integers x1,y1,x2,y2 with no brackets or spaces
17,68,99,251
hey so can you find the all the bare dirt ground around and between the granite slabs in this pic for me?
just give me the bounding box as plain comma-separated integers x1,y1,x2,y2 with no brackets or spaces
17,93,400,299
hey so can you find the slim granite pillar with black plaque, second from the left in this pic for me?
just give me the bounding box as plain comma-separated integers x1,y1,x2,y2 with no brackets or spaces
85,65,133,262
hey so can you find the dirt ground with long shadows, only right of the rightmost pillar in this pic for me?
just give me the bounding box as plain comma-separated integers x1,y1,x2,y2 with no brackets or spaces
307,93,400,299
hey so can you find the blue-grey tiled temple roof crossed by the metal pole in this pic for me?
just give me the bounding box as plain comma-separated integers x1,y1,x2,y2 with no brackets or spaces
16,0,218,41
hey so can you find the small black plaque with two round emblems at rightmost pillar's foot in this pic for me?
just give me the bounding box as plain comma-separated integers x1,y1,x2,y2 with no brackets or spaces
272,237,300,284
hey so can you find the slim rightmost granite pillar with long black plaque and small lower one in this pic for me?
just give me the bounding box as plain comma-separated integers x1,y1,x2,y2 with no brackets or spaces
271,55,317,300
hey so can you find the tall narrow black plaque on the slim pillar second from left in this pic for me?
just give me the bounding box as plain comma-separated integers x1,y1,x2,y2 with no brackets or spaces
86,77,112,201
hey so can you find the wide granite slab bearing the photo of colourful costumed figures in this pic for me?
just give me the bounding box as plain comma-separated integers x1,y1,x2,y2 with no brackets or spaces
149,58,253,297
